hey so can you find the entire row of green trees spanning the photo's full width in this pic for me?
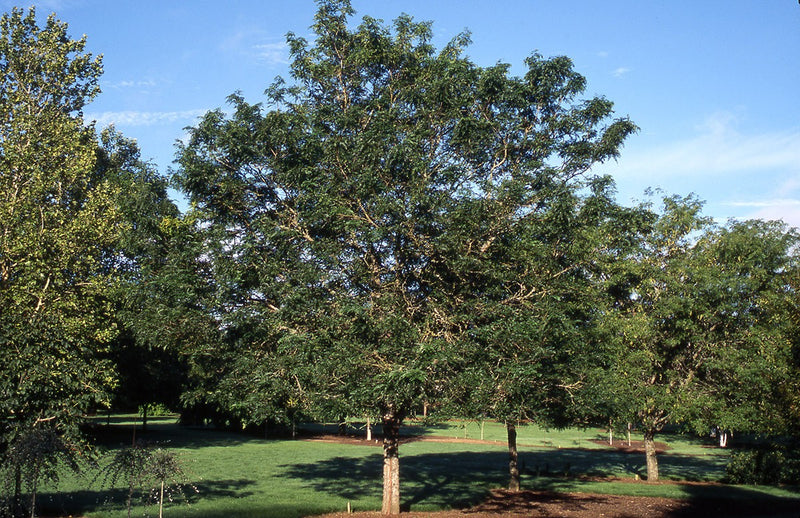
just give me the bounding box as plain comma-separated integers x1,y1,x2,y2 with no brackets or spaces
0,0,800,513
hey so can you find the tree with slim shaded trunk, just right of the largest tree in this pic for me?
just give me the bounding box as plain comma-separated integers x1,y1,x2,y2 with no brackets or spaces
450,178,630,490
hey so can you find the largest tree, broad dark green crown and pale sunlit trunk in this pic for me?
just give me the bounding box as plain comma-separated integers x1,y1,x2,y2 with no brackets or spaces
172,1,634,513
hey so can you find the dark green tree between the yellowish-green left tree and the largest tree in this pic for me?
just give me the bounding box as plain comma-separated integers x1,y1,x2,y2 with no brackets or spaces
95,127,187,428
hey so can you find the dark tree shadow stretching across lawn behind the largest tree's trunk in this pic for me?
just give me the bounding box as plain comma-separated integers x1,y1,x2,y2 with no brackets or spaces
281,449,732,510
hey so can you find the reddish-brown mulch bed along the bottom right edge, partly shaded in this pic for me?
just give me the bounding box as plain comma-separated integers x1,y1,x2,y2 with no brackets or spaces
320,490,800,518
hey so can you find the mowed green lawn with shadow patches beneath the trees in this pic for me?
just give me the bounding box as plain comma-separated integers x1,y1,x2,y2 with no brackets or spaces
39,417,800,518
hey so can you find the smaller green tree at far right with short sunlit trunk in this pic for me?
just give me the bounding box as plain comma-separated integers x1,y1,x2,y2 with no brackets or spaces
591,196,796,481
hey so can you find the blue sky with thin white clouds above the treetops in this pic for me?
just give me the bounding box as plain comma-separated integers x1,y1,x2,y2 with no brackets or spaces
7,0,800,227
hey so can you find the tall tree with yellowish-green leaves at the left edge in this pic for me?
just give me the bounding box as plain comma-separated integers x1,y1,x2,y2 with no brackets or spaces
0,9,121,513
